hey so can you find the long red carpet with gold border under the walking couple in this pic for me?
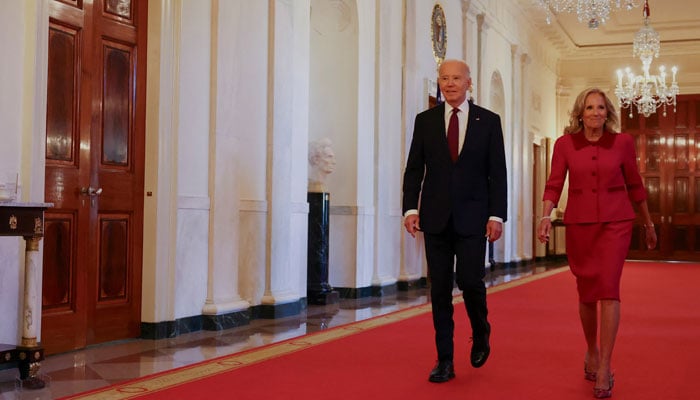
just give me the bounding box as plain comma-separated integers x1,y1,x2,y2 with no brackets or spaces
64,263,700,400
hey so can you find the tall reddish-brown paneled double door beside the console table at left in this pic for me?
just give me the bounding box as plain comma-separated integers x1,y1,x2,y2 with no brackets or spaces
41,0,147,353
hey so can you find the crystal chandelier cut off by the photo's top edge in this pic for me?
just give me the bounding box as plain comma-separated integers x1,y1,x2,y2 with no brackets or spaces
538,0,640,29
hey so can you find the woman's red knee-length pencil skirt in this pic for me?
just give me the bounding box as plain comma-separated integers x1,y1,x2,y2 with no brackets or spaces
566,220,634,303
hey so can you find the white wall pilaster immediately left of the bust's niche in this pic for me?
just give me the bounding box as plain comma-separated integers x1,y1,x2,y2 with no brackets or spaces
262,0,308,305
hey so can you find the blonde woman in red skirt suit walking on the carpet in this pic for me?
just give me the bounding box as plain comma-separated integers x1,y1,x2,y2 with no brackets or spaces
537,88,656,398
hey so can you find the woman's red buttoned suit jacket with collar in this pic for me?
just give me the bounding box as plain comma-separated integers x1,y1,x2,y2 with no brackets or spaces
543,131,647,224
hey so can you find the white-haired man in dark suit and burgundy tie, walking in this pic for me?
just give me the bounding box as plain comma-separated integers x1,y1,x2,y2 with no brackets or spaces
403,60,507,382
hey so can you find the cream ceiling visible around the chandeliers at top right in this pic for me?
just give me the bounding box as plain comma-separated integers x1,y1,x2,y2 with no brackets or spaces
519,0,700,55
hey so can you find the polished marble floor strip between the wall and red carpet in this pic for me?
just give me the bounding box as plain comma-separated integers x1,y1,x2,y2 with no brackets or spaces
0,258,565,400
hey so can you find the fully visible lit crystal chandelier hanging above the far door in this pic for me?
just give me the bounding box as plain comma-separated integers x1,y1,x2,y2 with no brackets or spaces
615,0,679,118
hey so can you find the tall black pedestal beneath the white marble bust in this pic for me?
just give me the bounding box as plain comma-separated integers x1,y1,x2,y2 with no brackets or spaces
306,192,340,305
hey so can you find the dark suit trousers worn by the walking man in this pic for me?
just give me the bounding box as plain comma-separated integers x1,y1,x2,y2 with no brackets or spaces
424,219,489,361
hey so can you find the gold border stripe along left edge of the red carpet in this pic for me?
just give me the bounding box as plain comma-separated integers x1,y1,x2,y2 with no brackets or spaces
71,267,568,400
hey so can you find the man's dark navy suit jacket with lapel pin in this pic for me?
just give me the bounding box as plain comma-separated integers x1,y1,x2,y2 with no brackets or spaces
403,103,508,236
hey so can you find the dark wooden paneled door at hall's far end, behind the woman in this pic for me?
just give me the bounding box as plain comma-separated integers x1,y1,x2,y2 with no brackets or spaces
622,95,700,261
